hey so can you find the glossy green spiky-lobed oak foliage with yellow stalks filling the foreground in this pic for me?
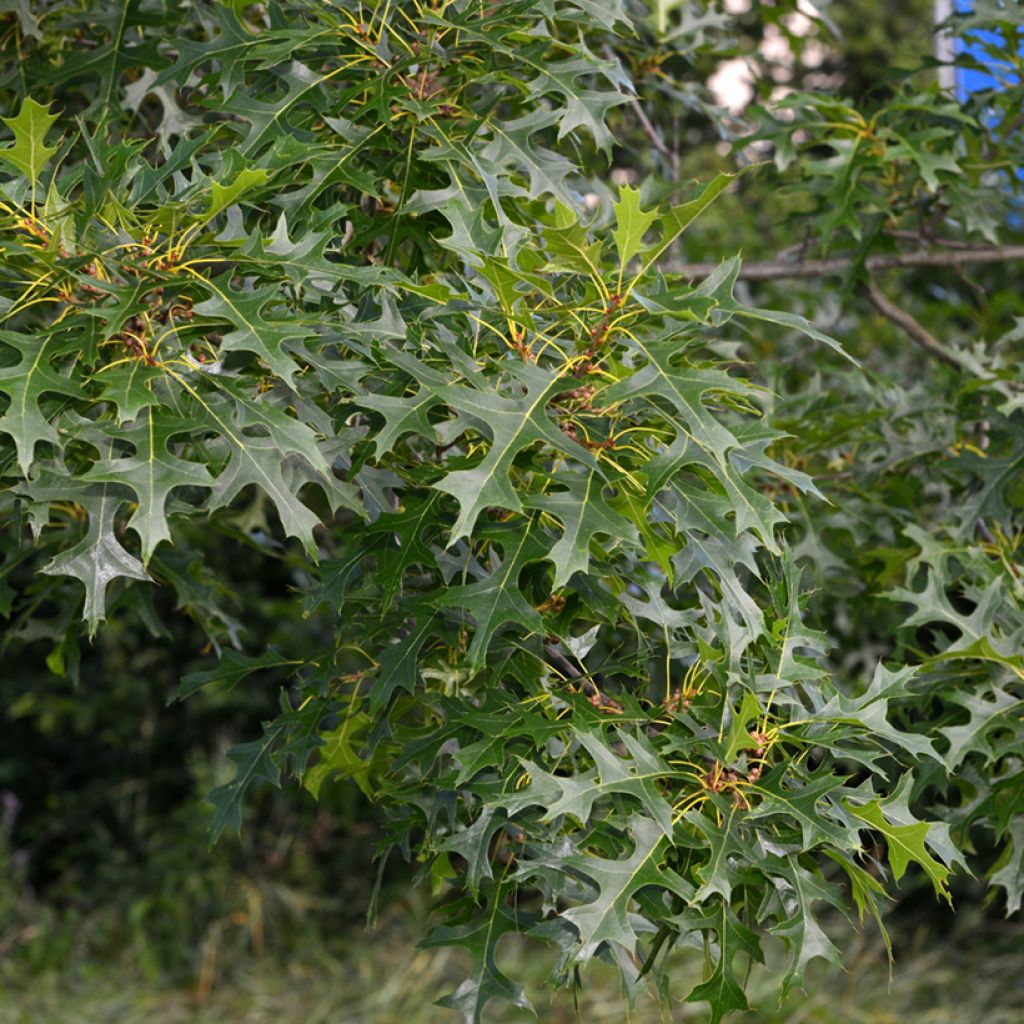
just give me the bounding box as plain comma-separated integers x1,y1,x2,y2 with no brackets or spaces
0,0,1024,1022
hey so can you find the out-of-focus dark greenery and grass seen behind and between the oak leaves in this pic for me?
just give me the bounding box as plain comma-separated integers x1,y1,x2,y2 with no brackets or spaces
0,0,1024,1024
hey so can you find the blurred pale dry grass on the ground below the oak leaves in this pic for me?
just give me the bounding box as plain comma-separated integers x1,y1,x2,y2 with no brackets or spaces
0,913,1024,1024
